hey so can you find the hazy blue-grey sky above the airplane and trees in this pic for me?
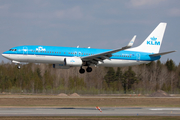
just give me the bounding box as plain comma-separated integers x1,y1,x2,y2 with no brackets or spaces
0,0,180,65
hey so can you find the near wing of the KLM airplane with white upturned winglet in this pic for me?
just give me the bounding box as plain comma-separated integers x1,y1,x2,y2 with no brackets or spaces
81,35,136,64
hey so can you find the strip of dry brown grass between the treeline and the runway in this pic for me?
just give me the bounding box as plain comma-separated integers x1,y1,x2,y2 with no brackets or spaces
0,95,180,108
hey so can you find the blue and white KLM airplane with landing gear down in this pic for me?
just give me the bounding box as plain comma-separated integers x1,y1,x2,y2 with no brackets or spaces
2,22,175,74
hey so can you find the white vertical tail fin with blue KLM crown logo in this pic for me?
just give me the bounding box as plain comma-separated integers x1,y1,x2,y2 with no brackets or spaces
130,23,167,53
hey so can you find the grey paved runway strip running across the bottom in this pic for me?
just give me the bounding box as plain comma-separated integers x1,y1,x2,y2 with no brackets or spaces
0,107,180,116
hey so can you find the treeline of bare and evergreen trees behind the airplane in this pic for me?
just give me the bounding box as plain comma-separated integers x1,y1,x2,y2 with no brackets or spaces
0,60,180,94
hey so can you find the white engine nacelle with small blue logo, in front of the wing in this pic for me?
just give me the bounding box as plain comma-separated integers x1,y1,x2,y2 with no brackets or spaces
64,57,83,67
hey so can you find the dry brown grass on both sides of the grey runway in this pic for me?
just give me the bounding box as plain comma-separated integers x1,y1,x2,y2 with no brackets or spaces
0,95,180,120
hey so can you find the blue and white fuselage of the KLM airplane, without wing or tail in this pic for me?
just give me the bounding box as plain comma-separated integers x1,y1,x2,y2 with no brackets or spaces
3,45,160,67
